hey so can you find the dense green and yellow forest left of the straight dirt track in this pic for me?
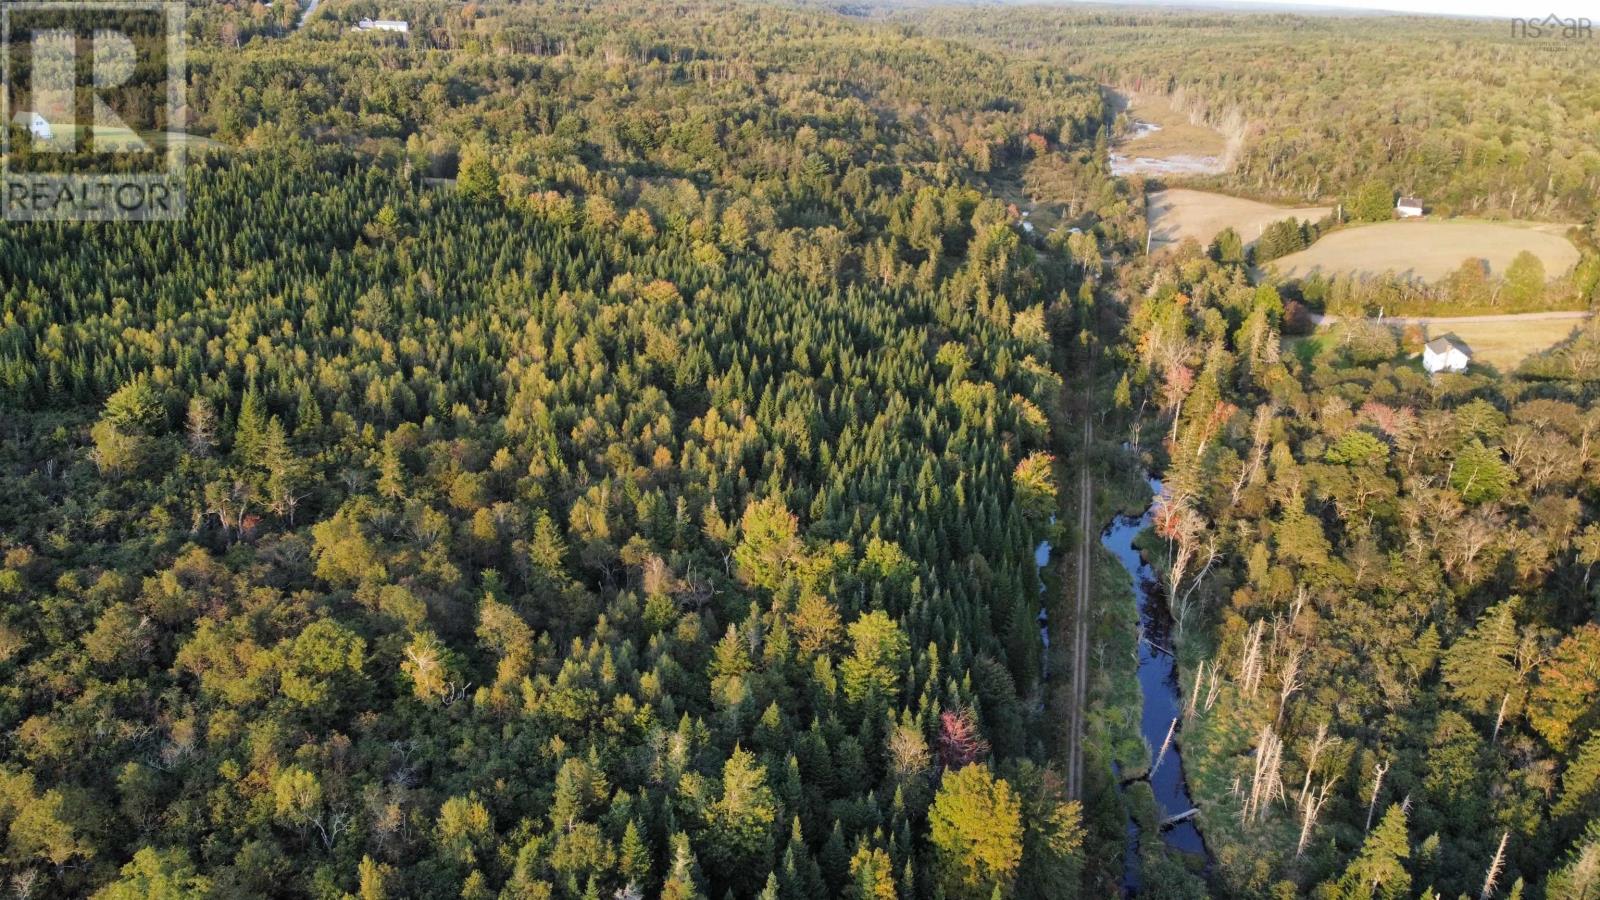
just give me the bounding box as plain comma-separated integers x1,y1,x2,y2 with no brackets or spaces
0,3,1142,898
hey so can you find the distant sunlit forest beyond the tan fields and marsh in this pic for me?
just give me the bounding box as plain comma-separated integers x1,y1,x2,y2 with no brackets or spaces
902,5,1600,223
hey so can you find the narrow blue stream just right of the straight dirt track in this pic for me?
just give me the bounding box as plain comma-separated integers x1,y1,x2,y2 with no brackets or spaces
1101,479,1206,894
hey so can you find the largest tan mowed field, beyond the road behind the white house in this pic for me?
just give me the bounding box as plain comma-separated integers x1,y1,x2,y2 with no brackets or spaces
1272,221,1578,282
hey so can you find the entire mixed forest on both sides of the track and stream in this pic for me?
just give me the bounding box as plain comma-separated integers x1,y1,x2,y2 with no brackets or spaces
0,0,1600,900
